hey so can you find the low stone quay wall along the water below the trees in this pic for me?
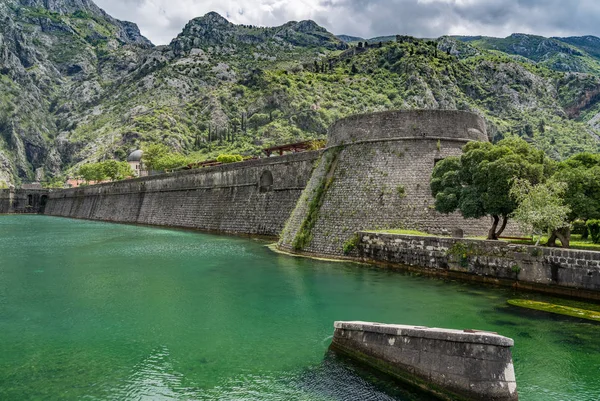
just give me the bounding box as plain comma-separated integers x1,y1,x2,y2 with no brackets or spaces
357,232,600,300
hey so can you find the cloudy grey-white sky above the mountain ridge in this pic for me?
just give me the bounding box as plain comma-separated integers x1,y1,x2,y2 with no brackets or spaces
96,0,600,44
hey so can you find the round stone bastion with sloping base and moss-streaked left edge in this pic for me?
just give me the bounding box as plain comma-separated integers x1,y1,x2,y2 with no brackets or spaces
279,110,489,255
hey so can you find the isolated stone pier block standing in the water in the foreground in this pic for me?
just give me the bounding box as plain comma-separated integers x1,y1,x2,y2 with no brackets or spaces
331,322,518,401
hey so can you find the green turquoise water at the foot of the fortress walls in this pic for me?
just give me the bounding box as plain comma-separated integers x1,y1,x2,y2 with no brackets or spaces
0,216,600,401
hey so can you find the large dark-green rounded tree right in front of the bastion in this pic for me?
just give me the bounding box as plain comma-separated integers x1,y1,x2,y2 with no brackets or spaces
431,138,550,240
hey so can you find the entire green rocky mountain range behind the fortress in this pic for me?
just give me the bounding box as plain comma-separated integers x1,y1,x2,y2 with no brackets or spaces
0,0,600,185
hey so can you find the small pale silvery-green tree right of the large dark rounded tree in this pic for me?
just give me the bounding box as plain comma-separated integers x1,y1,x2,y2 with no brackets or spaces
510,179,571,248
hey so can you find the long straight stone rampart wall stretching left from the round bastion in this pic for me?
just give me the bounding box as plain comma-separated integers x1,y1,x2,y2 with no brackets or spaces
45,152,320,236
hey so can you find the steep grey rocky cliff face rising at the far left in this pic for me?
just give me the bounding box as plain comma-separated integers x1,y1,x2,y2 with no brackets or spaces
0,0,152,182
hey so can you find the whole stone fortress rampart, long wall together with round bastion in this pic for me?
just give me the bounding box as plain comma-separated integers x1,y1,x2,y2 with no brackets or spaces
35,110,489,256
